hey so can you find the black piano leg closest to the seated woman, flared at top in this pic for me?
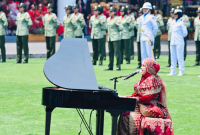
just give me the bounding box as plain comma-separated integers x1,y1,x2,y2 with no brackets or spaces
106,110,124,135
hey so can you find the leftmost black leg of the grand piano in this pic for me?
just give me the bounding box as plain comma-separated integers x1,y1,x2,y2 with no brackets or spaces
45,107,54,135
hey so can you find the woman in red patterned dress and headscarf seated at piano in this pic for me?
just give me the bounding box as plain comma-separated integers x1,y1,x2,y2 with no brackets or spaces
117,58,173,135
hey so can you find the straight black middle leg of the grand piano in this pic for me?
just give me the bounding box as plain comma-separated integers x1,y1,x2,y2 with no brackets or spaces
96,110,104,135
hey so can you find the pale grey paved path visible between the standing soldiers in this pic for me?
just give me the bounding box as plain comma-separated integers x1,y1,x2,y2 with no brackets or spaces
3,40,196,59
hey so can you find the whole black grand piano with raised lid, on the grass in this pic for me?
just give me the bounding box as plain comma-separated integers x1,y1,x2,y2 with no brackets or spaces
42,38,136,135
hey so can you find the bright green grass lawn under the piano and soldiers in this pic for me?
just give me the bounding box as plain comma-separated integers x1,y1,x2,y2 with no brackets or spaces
0,56,200,135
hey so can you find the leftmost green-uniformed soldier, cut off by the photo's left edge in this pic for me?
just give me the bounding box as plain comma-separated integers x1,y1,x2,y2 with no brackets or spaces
0,8,8,62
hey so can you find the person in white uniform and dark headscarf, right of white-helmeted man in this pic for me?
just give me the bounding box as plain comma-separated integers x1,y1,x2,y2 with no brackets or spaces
168,9,188,76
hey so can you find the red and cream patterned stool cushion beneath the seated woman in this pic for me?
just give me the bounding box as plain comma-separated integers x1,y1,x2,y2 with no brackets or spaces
141,117,173,135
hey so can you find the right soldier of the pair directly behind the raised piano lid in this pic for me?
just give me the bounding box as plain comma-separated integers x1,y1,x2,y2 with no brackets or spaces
71,4,86,38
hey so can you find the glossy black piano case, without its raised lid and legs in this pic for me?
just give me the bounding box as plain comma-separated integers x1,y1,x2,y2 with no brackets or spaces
42,87,135,111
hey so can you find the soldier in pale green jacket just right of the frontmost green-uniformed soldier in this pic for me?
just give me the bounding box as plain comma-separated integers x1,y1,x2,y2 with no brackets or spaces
119,7,134,64
